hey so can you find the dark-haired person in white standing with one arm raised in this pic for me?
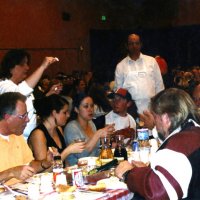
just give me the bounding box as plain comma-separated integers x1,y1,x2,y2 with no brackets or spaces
0,49,58,139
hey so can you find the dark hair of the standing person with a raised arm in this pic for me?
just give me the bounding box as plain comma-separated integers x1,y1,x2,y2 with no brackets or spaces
0,49,30,78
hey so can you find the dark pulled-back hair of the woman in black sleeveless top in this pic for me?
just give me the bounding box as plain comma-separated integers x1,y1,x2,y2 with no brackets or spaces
34,94,69,120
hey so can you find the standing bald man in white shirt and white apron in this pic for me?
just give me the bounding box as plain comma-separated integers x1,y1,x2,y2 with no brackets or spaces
115,34,164,113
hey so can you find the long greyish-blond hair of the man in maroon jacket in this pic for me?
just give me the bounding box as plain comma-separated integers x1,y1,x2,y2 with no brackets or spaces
150,88,200,132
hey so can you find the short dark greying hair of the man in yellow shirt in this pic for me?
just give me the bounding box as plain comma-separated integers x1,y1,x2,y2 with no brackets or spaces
0,92,26,120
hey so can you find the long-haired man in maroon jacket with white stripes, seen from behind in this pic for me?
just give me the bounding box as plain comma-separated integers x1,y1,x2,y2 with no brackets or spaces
115,88,200,200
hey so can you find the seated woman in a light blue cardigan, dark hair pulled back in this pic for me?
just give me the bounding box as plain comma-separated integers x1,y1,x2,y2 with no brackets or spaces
64,94,114,165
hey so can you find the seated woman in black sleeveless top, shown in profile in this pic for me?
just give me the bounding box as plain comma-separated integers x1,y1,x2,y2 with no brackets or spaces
28,94,85,166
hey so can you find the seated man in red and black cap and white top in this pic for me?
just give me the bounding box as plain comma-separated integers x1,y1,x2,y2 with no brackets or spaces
105,88,136,140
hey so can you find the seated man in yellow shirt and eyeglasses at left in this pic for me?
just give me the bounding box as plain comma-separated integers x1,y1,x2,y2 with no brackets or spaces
0,92,52,182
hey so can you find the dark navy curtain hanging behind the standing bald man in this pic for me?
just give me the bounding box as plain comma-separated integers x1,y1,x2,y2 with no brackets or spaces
90,25,200,80
